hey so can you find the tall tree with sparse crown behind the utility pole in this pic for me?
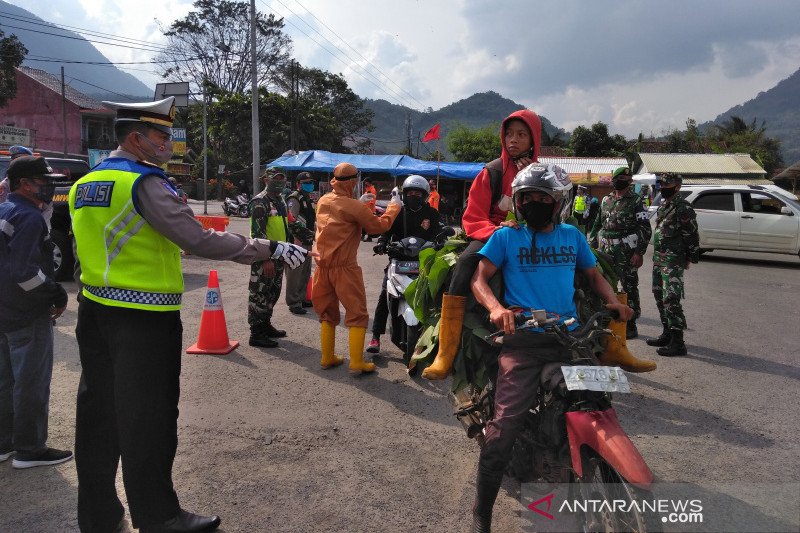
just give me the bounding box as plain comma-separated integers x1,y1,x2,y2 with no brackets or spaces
155,0,292,93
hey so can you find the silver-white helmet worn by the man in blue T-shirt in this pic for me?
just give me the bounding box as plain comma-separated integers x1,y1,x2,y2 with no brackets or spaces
511,163,572,224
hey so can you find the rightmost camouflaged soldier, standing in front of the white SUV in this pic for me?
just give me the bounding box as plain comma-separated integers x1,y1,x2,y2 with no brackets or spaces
647,174,700,357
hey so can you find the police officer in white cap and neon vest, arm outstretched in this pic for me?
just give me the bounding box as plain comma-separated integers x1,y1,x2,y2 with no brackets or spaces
69,97,307,533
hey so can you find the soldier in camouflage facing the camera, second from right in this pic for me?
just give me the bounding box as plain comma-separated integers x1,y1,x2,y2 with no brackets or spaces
588,167,652,339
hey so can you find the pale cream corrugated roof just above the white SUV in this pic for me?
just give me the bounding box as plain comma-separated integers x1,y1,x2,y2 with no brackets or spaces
636,154,766,176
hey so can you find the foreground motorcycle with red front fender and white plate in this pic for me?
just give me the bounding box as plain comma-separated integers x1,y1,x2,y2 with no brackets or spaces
451,310,661,532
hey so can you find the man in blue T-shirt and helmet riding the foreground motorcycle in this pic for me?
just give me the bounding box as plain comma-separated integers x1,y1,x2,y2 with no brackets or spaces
472,163,633,531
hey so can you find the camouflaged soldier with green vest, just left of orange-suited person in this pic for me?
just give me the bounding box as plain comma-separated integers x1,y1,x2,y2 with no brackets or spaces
247,168,290,348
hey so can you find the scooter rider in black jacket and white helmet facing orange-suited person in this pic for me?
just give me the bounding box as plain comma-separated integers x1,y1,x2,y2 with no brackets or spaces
367,174,445,353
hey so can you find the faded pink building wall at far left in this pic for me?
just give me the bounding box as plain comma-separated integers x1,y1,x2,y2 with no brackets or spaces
0,71,86,154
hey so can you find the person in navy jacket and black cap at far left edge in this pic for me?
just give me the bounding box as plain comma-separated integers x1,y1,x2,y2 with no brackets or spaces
0,156,72,468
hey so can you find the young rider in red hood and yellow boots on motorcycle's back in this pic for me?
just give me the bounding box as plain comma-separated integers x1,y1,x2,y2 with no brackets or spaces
422,109,542,379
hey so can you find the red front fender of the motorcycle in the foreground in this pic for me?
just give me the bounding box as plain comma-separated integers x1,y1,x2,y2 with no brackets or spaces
565,409,653,490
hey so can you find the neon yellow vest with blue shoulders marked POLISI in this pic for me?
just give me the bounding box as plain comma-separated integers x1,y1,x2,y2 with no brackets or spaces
69,157,183,311
